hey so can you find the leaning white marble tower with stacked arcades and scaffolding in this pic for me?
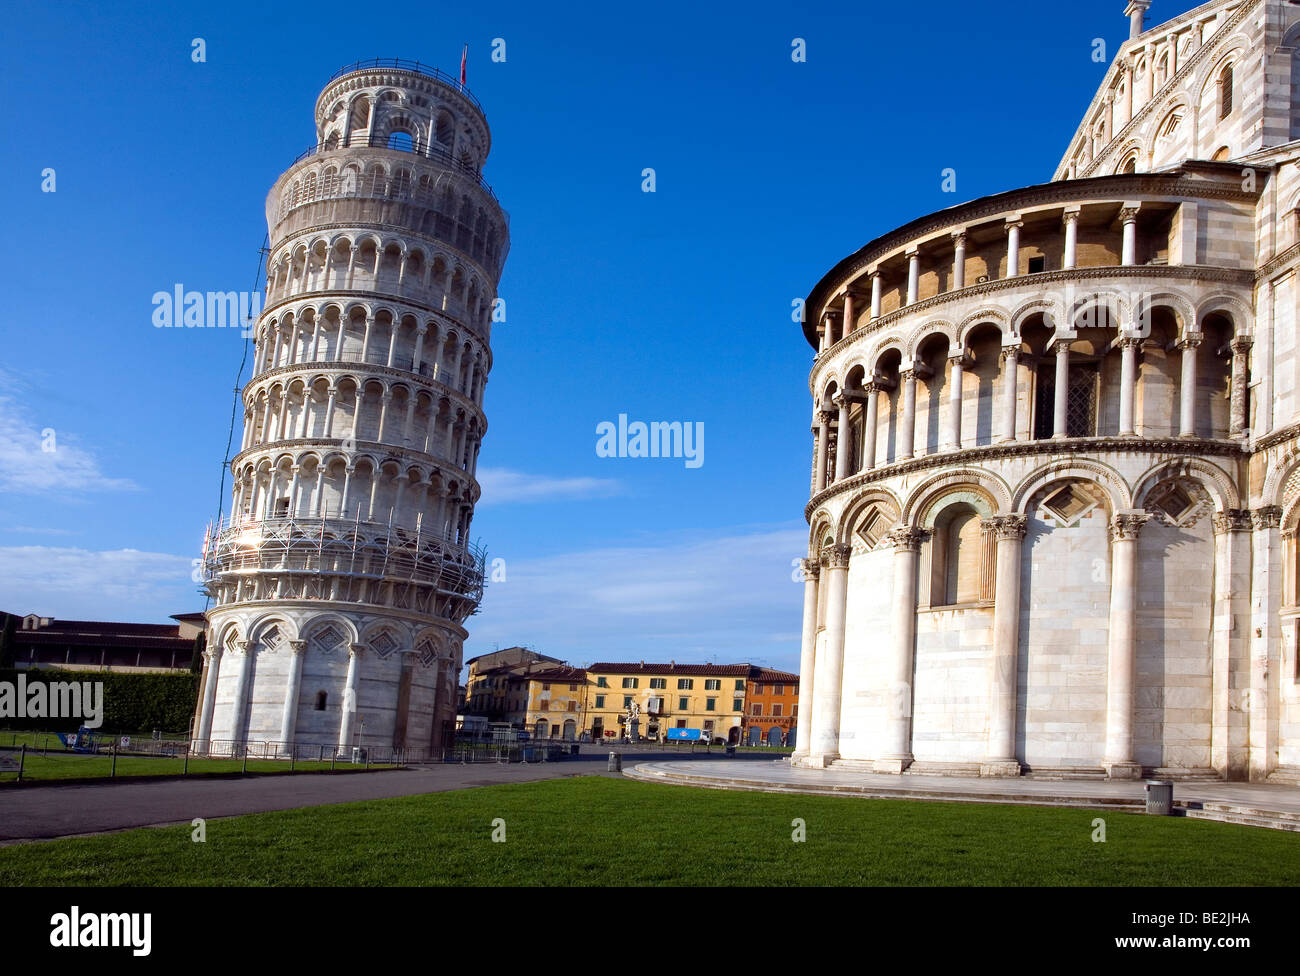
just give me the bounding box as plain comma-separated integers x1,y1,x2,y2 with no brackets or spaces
195,60,508,756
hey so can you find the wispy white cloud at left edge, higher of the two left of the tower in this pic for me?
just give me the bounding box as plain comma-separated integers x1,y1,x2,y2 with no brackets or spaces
0,389,138,495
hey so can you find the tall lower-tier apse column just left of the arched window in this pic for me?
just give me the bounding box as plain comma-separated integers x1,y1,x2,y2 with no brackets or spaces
874,525,926,773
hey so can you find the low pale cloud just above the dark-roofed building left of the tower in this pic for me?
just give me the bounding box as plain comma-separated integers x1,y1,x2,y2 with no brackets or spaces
0,546,204,621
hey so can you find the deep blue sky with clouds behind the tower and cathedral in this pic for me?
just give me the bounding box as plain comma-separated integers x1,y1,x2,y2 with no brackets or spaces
0,0,1193,669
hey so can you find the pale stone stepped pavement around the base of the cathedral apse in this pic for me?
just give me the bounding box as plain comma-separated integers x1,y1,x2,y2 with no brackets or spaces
624,759,1300,830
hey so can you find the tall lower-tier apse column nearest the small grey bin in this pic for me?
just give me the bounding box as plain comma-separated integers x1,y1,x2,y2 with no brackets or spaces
1101,512,1151,780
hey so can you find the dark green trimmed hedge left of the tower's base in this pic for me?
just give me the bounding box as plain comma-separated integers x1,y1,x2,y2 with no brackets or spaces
0,668,199,733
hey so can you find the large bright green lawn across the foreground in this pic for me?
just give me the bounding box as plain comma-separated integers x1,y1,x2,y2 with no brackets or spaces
0,777,1300,888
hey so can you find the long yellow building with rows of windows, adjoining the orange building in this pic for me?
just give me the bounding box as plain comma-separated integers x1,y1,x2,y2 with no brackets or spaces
579,661,758,742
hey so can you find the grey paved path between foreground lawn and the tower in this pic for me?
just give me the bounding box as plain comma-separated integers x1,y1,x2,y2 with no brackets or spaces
0,750,768,845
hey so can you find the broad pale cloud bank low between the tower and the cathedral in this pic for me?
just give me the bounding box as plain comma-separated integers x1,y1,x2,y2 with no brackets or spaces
465,526,807,671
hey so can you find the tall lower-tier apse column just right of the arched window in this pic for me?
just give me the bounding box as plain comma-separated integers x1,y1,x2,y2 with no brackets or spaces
980,515,1028,776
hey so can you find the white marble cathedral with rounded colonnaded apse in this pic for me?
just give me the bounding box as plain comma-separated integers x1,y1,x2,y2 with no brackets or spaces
793,0,1300,782
